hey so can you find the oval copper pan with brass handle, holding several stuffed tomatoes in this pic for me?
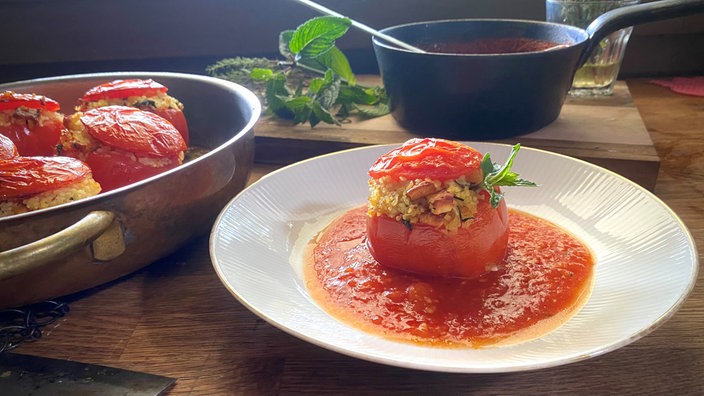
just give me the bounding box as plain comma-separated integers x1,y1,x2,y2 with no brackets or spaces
0,72,261,308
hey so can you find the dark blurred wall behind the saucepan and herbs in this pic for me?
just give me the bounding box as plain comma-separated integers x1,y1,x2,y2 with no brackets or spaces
0,0,704,82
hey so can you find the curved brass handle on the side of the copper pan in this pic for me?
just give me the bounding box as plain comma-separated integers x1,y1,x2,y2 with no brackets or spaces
0,211,125,280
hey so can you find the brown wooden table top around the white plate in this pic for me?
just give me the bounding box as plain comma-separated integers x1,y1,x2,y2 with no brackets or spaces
9,80,704,395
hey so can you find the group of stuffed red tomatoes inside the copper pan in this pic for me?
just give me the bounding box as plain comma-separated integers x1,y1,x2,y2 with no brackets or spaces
0,80,188,216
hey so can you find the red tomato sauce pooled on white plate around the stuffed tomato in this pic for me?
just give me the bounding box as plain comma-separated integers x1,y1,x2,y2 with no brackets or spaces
305,206,595,348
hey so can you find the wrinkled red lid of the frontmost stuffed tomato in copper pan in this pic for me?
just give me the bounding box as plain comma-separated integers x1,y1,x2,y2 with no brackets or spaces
0,157,91,198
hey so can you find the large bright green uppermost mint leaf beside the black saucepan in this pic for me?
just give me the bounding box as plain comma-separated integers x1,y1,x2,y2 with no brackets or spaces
289,16,352,61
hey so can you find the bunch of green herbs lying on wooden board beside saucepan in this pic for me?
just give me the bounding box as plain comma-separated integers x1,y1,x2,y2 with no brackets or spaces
206,16,389,126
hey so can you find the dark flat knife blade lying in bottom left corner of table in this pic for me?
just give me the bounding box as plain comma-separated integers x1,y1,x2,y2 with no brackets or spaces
0,353,176,396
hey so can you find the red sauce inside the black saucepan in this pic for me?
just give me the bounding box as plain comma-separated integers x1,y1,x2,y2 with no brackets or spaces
419,37,566,54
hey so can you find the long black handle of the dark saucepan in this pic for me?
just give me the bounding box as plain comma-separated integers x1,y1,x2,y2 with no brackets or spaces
577,0,704,67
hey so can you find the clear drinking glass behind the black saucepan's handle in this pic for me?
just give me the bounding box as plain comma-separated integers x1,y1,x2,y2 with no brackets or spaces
545,0,640,96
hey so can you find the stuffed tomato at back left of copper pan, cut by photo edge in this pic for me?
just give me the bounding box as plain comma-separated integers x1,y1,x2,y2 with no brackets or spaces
0,91,64,156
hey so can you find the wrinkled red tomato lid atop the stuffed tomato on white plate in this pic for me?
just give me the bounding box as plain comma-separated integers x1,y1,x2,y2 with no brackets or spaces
369,138,483,181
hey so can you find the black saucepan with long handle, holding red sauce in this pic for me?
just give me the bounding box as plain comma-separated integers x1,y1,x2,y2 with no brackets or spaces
372,0,704,139
